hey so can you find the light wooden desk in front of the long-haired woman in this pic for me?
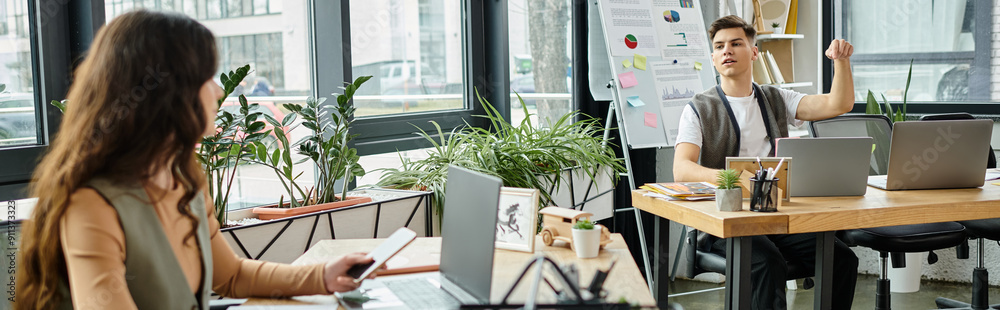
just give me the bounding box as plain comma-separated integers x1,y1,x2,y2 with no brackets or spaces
246,234,656,306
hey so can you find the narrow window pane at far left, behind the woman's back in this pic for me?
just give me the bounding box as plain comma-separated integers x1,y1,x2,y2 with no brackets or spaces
0,1,36,148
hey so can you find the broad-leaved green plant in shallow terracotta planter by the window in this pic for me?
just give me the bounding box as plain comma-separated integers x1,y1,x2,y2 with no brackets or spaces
250,76,371,220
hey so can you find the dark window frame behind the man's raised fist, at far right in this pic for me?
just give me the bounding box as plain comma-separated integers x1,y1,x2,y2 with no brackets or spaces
822,0,1000,115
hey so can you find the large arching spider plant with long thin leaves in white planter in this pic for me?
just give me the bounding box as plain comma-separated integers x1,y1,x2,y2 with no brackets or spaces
378,92,624,216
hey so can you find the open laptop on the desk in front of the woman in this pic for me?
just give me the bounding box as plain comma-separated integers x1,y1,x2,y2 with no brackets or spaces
342,166,503,309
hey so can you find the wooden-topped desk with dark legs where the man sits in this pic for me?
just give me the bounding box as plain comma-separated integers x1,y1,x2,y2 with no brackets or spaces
632,182,1000,309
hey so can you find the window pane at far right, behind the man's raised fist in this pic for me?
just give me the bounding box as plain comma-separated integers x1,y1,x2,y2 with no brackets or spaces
835,0,1000,103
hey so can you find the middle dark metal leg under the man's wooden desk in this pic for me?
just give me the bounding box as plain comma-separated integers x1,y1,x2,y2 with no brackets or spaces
726,237,753,310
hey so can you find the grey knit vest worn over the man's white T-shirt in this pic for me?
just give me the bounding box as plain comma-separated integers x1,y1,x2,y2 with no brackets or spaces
688,83,788,169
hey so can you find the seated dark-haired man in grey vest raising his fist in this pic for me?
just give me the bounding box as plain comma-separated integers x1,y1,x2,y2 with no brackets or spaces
673,15,858,310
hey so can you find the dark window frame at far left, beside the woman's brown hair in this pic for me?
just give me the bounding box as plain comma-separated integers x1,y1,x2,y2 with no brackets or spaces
0,0,94,200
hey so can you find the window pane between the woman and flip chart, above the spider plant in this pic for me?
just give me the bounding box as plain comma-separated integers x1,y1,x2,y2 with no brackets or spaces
350,0,465,117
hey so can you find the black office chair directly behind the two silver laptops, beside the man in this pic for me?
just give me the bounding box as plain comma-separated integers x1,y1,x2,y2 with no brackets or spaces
809,115,966,310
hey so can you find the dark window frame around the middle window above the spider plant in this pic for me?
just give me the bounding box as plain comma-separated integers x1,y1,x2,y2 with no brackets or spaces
307,0,510,156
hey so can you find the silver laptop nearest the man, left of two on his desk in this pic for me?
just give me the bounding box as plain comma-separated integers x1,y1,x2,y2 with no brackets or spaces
775,137,874,197
